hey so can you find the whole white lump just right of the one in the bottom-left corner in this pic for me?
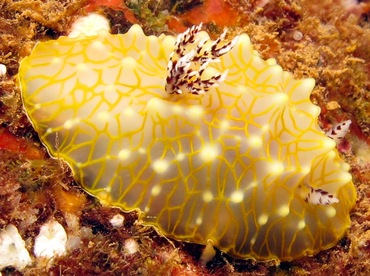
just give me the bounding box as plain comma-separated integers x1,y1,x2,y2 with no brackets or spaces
33,221,67,259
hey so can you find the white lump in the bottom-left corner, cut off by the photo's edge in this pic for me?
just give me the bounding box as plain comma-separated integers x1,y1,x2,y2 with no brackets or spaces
0,224,32,270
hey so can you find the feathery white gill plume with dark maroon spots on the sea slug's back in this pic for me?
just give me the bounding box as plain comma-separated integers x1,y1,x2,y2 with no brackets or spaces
165,24,238,95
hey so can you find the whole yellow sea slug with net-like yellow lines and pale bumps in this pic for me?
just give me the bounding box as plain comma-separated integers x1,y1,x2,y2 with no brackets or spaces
19,22,356,261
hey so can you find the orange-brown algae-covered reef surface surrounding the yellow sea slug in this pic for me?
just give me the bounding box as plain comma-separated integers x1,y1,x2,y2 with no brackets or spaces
0,0,370,275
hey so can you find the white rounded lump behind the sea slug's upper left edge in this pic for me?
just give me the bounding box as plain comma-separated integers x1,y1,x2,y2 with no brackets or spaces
68,13,110,38
